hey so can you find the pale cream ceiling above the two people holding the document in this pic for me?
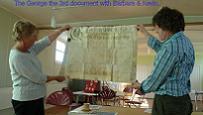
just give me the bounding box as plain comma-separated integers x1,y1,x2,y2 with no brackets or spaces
0,0,203,26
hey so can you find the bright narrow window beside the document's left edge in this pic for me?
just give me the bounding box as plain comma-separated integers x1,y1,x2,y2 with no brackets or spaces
55,32,67,63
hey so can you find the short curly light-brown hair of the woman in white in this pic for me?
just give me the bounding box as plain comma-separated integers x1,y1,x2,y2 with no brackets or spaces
12,21,37,41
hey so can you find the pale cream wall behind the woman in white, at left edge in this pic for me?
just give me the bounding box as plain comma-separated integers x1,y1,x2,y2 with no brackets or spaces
0,8,20,110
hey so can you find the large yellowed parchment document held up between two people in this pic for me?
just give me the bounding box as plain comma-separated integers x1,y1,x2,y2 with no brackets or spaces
60,26,137,82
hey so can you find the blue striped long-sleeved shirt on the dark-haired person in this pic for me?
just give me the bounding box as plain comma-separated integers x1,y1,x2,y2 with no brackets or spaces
141,32,195,96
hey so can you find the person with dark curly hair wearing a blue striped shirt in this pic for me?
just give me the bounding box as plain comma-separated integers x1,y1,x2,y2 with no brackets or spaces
136,7,195,115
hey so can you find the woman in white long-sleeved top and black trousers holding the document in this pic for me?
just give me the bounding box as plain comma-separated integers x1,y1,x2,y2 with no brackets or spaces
9,21,71,115
